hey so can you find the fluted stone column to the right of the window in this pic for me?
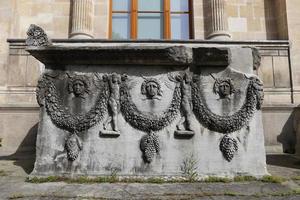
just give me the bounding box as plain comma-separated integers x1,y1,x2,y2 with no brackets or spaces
208,0,231,40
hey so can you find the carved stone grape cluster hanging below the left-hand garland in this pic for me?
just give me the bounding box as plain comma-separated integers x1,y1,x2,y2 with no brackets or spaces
65,134,82,161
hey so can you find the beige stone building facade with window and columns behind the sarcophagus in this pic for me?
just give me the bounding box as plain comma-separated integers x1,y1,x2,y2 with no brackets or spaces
0,0,300,156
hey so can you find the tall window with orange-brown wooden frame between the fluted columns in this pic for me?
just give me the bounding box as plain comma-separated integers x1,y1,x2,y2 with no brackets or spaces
109,0,193,39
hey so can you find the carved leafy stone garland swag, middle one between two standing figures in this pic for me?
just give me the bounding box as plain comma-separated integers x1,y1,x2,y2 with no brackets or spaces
120,77,181,133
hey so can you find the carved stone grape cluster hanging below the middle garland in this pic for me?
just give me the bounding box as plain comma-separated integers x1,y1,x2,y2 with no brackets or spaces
140,132,160,163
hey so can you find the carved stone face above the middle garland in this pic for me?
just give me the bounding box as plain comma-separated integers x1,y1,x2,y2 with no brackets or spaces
141,79,162,99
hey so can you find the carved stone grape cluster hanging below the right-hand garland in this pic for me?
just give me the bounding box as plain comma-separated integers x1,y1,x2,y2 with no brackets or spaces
220,134,238,162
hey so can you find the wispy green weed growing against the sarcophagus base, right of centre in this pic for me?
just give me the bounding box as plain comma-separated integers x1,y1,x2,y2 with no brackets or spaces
180,154,198,182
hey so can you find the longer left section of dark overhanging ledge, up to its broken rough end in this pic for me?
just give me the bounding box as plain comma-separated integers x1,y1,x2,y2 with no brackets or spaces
26,46,192,65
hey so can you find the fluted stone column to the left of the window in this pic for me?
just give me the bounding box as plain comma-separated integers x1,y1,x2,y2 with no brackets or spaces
70,0,94,39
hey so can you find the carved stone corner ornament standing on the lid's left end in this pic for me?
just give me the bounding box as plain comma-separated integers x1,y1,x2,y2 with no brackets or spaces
25,24,51,46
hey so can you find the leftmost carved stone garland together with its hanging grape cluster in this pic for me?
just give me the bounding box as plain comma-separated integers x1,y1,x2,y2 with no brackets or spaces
37,74,109,161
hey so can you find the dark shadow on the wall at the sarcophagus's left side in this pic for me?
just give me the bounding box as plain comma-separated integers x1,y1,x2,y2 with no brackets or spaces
0,123,38,174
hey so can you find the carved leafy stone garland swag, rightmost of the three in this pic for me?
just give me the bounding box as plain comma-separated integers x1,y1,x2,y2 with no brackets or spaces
192,77,263,133
